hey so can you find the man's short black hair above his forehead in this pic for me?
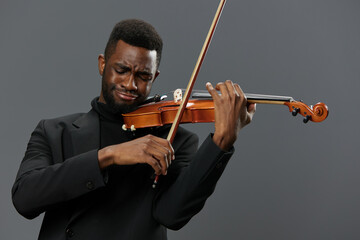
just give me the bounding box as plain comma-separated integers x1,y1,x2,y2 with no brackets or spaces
105,19,163,68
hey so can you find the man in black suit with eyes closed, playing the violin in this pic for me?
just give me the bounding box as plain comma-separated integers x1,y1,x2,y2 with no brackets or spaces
12,20,255,240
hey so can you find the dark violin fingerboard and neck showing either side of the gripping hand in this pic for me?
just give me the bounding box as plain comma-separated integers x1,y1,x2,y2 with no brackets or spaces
192,92,294,104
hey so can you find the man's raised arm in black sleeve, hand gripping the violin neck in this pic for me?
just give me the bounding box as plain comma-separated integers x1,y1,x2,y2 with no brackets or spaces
154,81,255,230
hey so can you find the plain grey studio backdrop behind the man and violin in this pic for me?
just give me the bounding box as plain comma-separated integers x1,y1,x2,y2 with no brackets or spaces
0,0,360,240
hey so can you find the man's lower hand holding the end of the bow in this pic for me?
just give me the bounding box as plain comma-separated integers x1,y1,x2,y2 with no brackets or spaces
98,135,175,175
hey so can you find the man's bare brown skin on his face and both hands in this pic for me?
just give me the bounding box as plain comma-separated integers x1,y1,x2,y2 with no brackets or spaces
98,40,255,175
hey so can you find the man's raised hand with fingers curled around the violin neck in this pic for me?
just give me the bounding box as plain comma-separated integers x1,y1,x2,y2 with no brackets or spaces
206,80,256,151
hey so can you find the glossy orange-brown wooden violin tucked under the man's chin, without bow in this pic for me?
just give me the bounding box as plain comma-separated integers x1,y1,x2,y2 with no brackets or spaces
123,92,329,131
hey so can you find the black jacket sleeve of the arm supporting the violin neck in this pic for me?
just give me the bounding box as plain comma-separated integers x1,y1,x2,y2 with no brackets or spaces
153,135,234,230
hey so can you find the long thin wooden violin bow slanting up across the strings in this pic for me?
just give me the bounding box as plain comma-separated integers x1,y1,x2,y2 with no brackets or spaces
153,0,226,188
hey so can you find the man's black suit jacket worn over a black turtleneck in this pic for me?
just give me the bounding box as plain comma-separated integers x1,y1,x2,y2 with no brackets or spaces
12,110,233,240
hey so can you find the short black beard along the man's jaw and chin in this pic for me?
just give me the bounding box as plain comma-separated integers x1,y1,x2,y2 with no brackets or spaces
101,79,146,114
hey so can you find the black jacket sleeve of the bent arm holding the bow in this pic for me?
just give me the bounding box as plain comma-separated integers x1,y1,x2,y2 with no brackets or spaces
12,120,105,219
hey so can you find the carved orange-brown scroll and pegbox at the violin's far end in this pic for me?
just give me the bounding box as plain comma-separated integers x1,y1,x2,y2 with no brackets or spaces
284,101,329,123
